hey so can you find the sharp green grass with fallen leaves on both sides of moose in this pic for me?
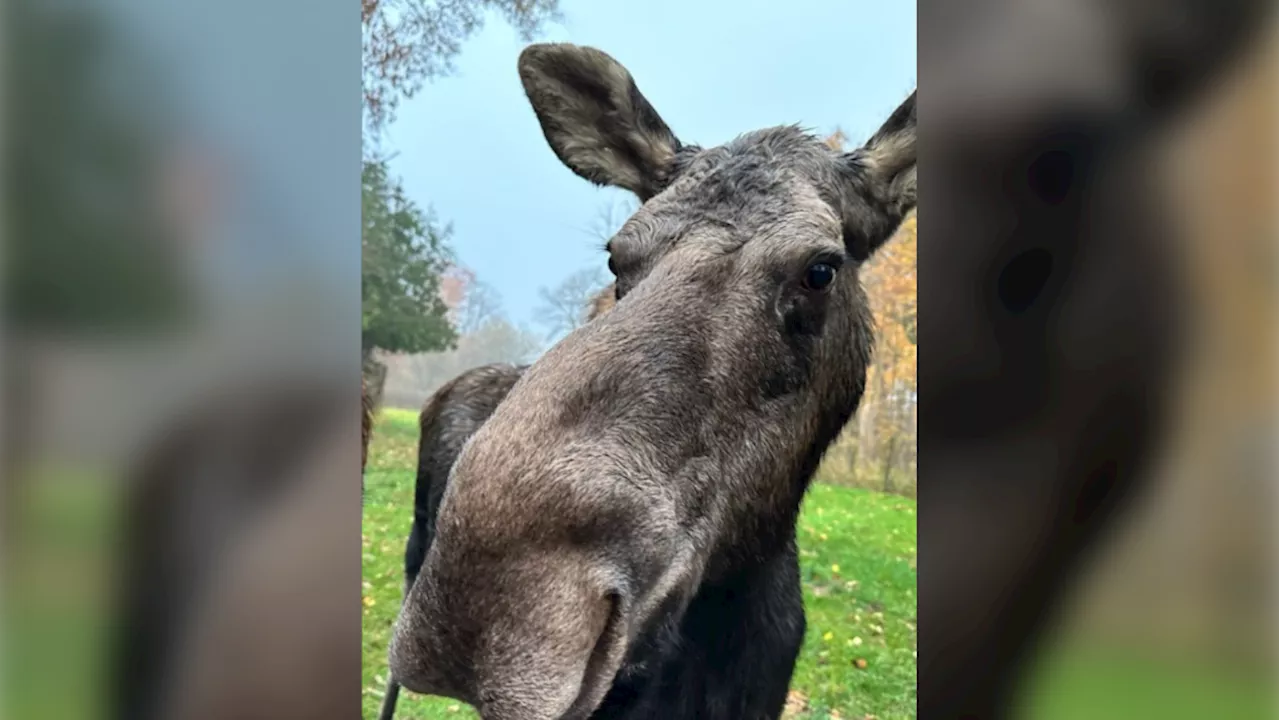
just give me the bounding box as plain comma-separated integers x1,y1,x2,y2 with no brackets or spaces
362,410,915,720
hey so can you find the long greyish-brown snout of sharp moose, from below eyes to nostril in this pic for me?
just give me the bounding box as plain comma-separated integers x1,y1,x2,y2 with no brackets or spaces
389,310,690,720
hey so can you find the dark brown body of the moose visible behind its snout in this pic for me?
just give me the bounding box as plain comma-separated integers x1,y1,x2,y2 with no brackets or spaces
376,283,617,720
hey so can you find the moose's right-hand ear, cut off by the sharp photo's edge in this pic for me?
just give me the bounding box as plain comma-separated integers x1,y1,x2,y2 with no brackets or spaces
841,91,915,260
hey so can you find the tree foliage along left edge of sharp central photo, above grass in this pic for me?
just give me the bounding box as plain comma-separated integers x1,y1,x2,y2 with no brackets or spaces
360,0,559,368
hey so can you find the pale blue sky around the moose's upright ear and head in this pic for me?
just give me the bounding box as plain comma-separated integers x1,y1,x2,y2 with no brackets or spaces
384,0,915,325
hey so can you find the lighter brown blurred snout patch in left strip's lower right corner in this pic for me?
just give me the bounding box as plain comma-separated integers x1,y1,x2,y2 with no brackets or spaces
160,397,360,720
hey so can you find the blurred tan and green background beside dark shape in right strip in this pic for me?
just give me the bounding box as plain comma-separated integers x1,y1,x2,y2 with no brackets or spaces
1013,20,1280,719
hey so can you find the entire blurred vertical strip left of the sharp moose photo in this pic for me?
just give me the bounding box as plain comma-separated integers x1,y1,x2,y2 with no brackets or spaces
0,0,360,720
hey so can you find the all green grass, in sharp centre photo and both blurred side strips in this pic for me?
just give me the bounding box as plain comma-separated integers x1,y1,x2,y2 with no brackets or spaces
0,411,1280,720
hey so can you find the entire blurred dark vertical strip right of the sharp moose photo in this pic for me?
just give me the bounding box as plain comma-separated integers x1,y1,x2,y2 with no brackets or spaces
918,0,1280,720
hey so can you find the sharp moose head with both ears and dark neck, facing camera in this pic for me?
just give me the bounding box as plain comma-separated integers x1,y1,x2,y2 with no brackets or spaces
389,44,916,720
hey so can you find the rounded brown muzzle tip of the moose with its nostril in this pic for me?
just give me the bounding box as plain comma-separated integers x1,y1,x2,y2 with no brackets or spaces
389,538,628,720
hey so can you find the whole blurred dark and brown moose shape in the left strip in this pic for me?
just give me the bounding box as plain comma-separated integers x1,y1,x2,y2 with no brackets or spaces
106,373,355,720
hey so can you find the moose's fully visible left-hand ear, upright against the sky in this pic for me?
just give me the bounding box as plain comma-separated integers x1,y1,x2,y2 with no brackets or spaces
520,44,680,202
